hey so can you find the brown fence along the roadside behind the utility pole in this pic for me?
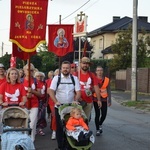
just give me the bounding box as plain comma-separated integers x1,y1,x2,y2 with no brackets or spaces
115,68,150,93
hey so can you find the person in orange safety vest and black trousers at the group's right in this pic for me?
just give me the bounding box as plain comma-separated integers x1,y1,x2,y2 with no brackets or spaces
93,66,111,136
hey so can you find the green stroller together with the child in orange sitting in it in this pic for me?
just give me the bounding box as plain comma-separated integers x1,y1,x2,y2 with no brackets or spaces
59,104,95,150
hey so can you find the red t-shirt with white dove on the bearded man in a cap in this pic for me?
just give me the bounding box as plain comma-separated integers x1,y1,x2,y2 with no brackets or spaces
76,71,98,103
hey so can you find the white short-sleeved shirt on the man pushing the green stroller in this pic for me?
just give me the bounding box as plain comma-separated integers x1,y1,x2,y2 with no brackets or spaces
50,73,80,104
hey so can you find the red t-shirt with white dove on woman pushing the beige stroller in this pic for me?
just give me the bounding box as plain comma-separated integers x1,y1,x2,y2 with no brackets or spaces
0,82,26,104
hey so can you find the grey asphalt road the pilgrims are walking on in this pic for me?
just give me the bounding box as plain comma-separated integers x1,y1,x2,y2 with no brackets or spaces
35,92,150,150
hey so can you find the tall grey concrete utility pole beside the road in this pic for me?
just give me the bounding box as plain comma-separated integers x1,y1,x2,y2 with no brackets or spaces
131,0,138,101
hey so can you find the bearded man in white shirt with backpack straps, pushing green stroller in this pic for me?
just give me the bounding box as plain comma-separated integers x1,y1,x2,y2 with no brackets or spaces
48,61,81,150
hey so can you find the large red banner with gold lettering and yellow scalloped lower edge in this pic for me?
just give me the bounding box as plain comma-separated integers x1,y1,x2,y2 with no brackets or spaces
10,0,48,52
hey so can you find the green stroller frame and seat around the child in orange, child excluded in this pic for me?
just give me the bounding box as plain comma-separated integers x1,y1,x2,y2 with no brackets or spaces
59,104,93,150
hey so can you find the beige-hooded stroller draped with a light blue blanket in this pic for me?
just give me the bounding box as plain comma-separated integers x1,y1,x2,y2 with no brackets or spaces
0,106,35,150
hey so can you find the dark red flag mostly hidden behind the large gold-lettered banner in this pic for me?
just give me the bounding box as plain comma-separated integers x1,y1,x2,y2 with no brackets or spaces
12,43,36,60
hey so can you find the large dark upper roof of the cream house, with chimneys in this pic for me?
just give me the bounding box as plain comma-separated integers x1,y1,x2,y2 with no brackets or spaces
87,16,150,37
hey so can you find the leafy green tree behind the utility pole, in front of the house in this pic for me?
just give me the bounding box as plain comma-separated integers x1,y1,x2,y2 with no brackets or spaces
109,27,149,72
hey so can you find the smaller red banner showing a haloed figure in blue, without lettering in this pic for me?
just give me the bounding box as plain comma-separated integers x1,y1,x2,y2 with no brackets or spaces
48,25,73,56
